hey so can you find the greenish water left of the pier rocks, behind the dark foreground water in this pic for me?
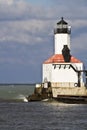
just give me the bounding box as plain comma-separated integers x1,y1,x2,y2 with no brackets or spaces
0,84,35,101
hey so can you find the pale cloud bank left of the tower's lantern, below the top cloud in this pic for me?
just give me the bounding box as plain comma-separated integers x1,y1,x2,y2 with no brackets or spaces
0,20,53,45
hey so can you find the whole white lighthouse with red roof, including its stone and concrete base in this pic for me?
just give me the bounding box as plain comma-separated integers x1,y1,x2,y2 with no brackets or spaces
28,17,87,103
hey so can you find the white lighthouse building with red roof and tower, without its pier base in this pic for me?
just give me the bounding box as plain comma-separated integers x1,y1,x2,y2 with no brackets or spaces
42,18,84,96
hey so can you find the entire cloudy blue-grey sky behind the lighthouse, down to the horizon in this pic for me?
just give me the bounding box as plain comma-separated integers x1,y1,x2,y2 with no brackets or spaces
0,0,87,83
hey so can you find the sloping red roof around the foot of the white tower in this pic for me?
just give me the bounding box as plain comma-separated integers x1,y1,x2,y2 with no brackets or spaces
44,54,81,64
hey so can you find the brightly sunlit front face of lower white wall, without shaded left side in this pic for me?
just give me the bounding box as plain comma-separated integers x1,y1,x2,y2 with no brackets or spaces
51,63,83,83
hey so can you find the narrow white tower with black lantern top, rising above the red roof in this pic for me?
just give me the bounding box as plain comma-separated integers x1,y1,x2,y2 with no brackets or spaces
54,17,71,54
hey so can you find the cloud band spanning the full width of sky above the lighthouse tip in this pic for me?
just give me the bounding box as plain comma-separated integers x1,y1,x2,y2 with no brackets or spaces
0,0,87,20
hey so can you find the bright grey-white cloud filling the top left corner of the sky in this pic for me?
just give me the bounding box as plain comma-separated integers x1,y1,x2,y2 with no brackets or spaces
0,0,52,21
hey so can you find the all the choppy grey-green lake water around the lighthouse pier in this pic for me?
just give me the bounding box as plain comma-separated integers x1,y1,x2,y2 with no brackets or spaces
0,85,87,130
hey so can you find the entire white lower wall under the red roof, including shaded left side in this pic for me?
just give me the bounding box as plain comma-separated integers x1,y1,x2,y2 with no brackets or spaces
42,63,83,83
